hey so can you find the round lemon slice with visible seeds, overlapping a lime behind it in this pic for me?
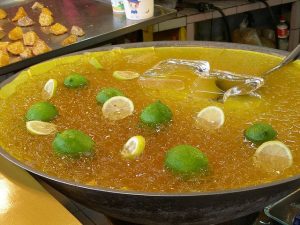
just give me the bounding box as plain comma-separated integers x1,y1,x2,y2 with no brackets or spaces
102,96,134,120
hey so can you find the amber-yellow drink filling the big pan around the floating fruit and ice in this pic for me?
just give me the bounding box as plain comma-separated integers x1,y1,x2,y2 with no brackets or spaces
0,48,300,192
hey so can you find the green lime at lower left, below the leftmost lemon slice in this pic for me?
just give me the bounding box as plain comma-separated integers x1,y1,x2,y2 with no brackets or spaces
52,130,94,156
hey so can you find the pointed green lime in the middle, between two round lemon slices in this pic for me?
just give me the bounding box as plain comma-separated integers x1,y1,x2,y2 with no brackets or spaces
140,101,173,126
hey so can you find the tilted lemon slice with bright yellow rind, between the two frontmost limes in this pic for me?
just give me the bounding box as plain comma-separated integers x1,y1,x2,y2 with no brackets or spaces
121,136,145,159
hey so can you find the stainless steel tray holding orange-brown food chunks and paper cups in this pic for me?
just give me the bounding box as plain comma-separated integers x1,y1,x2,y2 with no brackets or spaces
0,0,176,75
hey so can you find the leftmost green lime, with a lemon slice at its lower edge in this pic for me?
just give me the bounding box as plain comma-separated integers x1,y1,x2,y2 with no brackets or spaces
25,102,58,122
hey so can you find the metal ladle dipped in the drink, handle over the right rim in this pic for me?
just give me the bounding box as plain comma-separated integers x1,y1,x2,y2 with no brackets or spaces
216,44,300,102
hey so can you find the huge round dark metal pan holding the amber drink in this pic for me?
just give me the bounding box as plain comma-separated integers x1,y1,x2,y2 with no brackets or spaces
0,42,300,225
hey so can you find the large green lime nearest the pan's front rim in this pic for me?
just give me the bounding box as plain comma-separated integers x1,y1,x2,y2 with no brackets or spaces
165,145,208,176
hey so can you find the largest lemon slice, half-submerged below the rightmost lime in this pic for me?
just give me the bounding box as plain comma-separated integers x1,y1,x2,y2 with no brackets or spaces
253,141,293,172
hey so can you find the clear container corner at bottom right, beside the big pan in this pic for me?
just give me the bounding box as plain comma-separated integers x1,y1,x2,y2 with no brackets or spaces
264,189,300,225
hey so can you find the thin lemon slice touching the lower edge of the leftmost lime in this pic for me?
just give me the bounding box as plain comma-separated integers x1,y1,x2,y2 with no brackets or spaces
26,120,57,135
